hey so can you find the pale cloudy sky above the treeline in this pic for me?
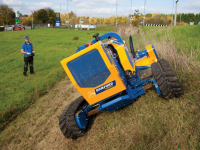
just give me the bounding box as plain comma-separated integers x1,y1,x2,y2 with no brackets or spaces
0,0,200,17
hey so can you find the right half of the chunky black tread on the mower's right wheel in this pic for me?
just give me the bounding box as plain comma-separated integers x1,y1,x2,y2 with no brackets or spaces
158,59,183,97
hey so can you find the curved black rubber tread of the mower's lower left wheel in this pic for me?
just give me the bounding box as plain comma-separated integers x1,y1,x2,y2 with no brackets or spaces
59,96,86,139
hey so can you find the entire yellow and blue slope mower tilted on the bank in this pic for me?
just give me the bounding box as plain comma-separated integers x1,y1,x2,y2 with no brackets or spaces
59,32,183,139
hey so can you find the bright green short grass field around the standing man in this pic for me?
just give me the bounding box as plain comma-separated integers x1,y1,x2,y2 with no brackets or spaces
0,27,112,129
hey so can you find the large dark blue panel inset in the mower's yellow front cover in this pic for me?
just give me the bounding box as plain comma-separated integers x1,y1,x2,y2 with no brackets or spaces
67,49,111,88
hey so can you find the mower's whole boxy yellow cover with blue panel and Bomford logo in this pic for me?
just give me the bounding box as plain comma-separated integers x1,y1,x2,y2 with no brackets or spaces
61,41,126,105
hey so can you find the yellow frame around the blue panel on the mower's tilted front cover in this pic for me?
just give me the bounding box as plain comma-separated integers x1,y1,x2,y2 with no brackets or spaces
61,41,126,105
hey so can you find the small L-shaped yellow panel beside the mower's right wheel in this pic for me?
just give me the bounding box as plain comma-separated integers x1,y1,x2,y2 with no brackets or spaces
135,45,157,66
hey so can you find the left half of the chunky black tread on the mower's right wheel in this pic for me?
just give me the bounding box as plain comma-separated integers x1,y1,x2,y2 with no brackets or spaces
151,62,172,99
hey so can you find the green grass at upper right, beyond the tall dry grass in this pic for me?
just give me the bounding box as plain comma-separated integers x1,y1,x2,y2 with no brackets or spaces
139,25,200,60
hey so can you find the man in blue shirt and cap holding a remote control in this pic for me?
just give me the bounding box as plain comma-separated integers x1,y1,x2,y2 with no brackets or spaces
21,36,35,76
